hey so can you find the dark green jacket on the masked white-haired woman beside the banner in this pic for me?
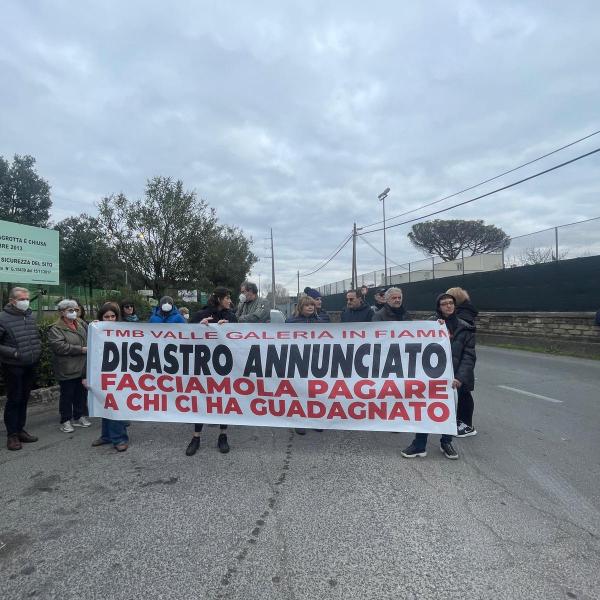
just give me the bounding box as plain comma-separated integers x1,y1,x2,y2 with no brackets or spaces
48,319,87,381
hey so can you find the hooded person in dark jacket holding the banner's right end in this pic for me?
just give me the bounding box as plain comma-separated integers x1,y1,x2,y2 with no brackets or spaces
401,294,476,460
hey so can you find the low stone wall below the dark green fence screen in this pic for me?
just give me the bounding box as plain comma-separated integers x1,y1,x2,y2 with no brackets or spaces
329,311,600,357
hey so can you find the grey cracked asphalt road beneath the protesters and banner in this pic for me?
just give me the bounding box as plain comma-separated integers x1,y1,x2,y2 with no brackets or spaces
0,348,600,600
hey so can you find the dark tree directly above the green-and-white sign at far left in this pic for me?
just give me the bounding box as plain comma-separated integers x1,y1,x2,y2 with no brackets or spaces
0,154,52,227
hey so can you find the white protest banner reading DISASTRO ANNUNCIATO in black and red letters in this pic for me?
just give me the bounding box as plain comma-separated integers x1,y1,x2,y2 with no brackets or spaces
87,321,456,434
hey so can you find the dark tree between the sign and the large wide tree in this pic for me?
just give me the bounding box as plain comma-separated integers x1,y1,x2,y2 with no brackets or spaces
56,214,124,298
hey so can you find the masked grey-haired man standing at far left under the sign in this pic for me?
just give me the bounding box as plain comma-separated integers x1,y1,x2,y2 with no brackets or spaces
0,287,42,450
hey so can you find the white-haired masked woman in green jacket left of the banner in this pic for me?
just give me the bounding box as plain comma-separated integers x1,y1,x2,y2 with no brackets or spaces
48,300,91,433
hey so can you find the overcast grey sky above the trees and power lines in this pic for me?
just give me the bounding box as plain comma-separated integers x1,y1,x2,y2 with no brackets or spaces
0,0,600,291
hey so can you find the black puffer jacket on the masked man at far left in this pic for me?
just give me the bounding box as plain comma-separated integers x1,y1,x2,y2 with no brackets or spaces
0,303,42,367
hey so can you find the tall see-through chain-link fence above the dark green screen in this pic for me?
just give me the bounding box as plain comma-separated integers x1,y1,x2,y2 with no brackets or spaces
317,217,600,296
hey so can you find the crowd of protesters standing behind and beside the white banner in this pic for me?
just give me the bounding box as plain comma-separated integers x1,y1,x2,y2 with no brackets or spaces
0,282,477,459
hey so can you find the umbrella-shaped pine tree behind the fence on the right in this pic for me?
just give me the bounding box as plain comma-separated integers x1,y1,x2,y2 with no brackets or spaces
408,219,510,261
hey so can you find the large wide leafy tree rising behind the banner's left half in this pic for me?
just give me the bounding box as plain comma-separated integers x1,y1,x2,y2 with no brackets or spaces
99,177,256,296
